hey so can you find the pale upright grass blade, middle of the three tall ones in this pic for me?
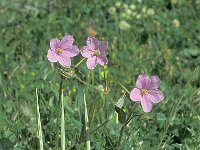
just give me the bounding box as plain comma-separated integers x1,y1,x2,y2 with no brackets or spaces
61,89,65,150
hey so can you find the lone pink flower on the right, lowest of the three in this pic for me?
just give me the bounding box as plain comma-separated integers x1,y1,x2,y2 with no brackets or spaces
130,75,164,112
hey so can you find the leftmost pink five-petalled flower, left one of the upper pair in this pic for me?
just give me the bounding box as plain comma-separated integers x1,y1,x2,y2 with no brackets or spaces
47,35,79,67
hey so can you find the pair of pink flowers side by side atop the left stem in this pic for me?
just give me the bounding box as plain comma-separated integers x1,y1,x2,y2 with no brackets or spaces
47,35,108,70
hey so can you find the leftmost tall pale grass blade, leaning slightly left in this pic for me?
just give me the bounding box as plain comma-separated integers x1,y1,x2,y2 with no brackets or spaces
35,88,44,150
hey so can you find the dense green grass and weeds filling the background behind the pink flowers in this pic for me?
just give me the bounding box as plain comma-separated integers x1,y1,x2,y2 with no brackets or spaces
0,0,200,150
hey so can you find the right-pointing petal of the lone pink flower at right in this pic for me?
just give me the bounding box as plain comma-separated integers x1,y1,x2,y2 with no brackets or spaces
146,90,164,103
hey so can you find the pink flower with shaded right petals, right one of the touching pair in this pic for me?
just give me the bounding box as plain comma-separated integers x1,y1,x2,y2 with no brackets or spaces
81,37,108,70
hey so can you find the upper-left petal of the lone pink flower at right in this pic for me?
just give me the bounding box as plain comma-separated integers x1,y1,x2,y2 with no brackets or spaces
136,74,151,89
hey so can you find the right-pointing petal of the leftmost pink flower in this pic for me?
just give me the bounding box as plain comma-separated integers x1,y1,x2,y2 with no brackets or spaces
61,45,79,57
